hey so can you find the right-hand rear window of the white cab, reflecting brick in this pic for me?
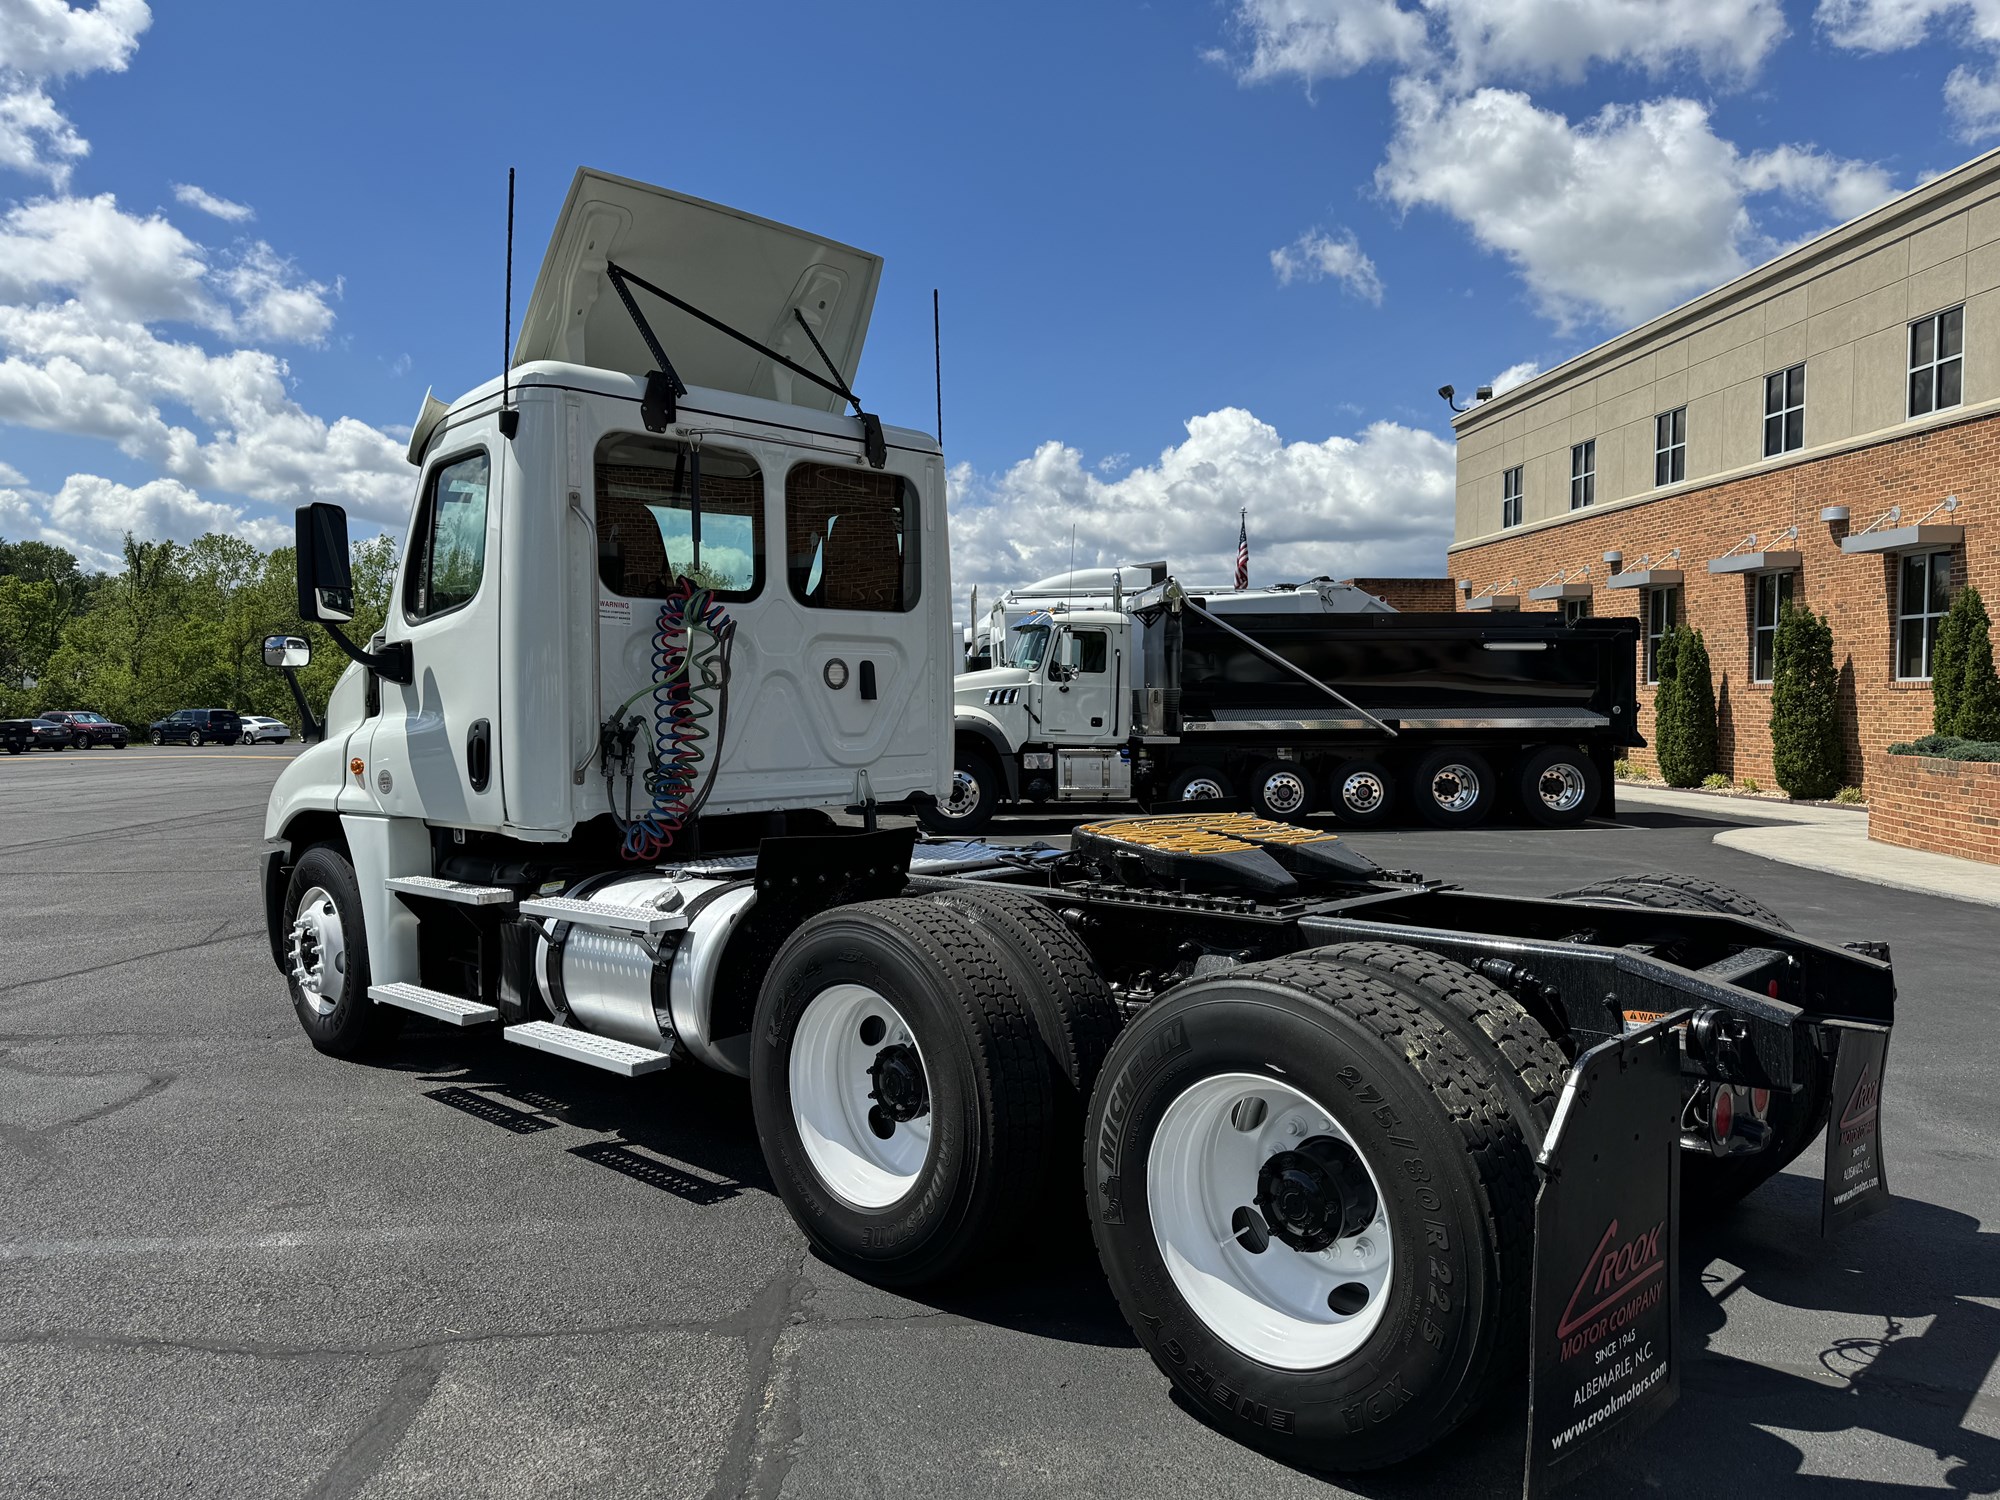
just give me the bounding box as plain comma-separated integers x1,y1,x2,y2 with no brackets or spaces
784,464,918,614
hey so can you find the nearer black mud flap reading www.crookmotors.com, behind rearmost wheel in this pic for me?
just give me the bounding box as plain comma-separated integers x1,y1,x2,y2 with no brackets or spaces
1522,1010,1690,1500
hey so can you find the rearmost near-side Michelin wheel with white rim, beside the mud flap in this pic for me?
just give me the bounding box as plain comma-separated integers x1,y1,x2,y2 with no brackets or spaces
1086,958,1536,1470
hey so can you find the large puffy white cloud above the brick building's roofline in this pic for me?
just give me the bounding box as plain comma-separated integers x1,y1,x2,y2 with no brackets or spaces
1376,80,1890,328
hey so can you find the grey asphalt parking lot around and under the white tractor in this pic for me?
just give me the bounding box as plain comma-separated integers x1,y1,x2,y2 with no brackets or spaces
0,748,2000,1500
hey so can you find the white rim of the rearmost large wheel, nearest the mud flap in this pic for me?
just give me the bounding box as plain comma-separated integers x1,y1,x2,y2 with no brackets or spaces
1146,1072,1394,1370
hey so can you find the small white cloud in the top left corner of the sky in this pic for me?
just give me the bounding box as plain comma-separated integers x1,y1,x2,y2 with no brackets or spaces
0,0,152,188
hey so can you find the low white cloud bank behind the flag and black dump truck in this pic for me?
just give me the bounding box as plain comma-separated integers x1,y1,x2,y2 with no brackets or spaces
952,408,1454,592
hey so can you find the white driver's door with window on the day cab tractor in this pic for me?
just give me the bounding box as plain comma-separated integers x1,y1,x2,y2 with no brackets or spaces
364,440,506,828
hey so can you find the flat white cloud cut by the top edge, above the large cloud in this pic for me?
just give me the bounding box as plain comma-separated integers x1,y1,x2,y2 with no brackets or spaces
1218,0,1784,88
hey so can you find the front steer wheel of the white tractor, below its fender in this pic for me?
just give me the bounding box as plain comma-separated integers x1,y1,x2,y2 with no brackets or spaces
282,844,402,1058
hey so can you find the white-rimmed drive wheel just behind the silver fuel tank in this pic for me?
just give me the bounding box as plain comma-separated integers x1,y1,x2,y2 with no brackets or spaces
750,898,1052,1284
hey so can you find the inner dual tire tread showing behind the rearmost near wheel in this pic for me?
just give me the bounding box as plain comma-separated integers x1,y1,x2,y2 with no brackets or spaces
1298,942,1570,1152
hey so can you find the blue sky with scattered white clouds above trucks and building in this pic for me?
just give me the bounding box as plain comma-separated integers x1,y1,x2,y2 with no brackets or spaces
0,0,2000,584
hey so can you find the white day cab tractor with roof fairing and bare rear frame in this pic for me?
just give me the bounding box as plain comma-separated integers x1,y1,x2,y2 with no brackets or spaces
262,172,1894,1482
